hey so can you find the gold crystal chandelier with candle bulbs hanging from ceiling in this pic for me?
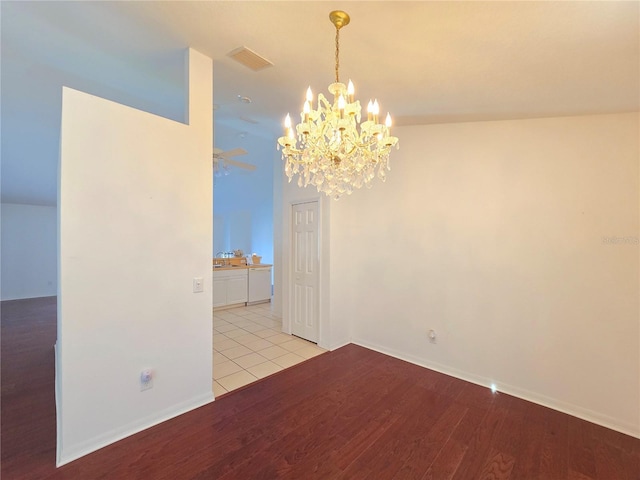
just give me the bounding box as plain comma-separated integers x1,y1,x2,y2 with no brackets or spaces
278,11,398,200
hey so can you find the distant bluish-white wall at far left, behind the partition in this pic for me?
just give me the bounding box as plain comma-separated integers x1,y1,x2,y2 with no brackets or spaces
1,203,58,300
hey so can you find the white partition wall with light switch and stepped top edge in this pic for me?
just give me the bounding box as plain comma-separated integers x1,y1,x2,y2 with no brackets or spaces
56,50,213,465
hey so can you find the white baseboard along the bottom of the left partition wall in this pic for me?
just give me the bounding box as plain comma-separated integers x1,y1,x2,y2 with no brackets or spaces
56,392,213,467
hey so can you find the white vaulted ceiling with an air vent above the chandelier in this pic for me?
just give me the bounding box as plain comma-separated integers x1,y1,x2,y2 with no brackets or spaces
1,1,640,204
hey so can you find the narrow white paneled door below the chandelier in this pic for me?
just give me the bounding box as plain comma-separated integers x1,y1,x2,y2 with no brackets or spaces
290,201,320,343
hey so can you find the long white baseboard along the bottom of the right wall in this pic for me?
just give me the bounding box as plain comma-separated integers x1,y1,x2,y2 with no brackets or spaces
352,339,640,438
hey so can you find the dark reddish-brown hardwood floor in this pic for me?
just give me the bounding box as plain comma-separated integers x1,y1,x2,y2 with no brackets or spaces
1,298,640,480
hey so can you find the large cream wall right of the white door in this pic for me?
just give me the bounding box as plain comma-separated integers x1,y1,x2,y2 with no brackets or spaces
331,113,640,436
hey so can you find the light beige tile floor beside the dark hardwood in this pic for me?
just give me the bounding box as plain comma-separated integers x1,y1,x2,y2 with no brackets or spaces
213,303,325,397
